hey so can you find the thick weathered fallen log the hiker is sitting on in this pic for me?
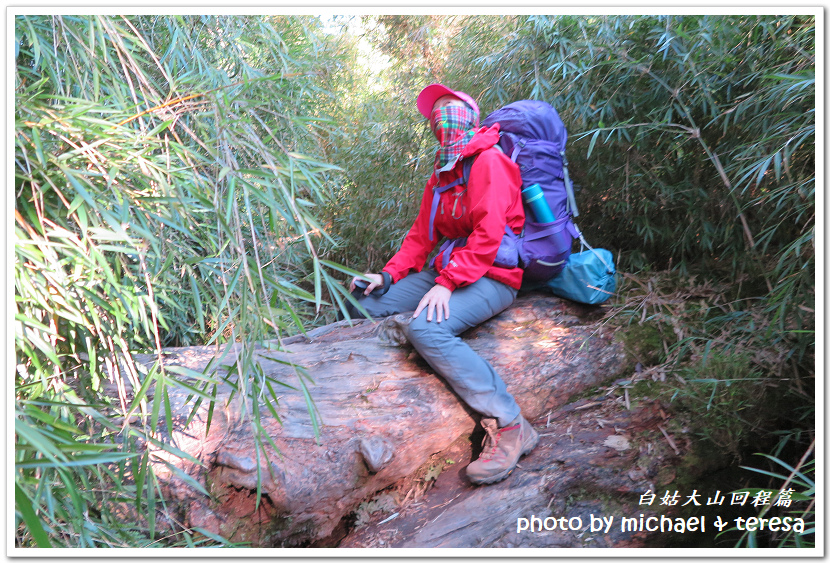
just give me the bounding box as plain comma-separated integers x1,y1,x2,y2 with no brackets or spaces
140,294,628,546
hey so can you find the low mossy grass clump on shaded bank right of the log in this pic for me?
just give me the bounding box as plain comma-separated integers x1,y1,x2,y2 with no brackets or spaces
606,273,815,458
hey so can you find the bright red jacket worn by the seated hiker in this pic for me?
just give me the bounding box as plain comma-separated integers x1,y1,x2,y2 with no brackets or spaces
383,123,525,290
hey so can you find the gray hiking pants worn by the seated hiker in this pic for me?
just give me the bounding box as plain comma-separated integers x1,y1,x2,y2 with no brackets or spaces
360,269,519,427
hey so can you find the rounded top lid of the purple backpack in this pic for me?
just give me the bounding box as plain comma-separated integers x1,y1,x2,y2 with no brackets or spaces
483,100,568,150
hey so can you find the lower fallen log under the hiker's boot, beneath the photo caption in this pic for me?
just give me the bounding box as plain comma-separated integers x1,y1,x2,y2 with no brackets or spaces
338,394,688,555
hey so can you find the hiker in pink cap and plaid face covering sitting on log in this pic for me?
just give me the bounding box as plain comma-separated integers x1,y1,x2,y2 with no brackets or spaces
350,84,539,484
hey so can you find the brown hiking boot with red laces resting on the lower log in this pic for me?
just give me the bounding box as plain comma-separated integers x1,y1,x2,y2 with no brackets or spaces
467,415,539,485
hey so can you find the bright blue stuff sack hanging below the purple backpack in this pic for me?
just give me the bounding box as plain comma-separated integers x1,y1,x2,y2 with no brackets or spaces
545,240,617,305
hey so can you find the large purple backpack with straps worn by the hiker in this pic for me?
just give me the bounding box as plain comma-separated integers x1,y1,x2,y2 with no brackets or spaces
430,100,579,285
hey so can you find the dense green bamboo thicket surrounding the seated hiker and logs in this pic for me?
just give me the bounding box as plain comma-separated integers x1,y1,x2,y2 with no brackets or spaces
14,15,816,546
